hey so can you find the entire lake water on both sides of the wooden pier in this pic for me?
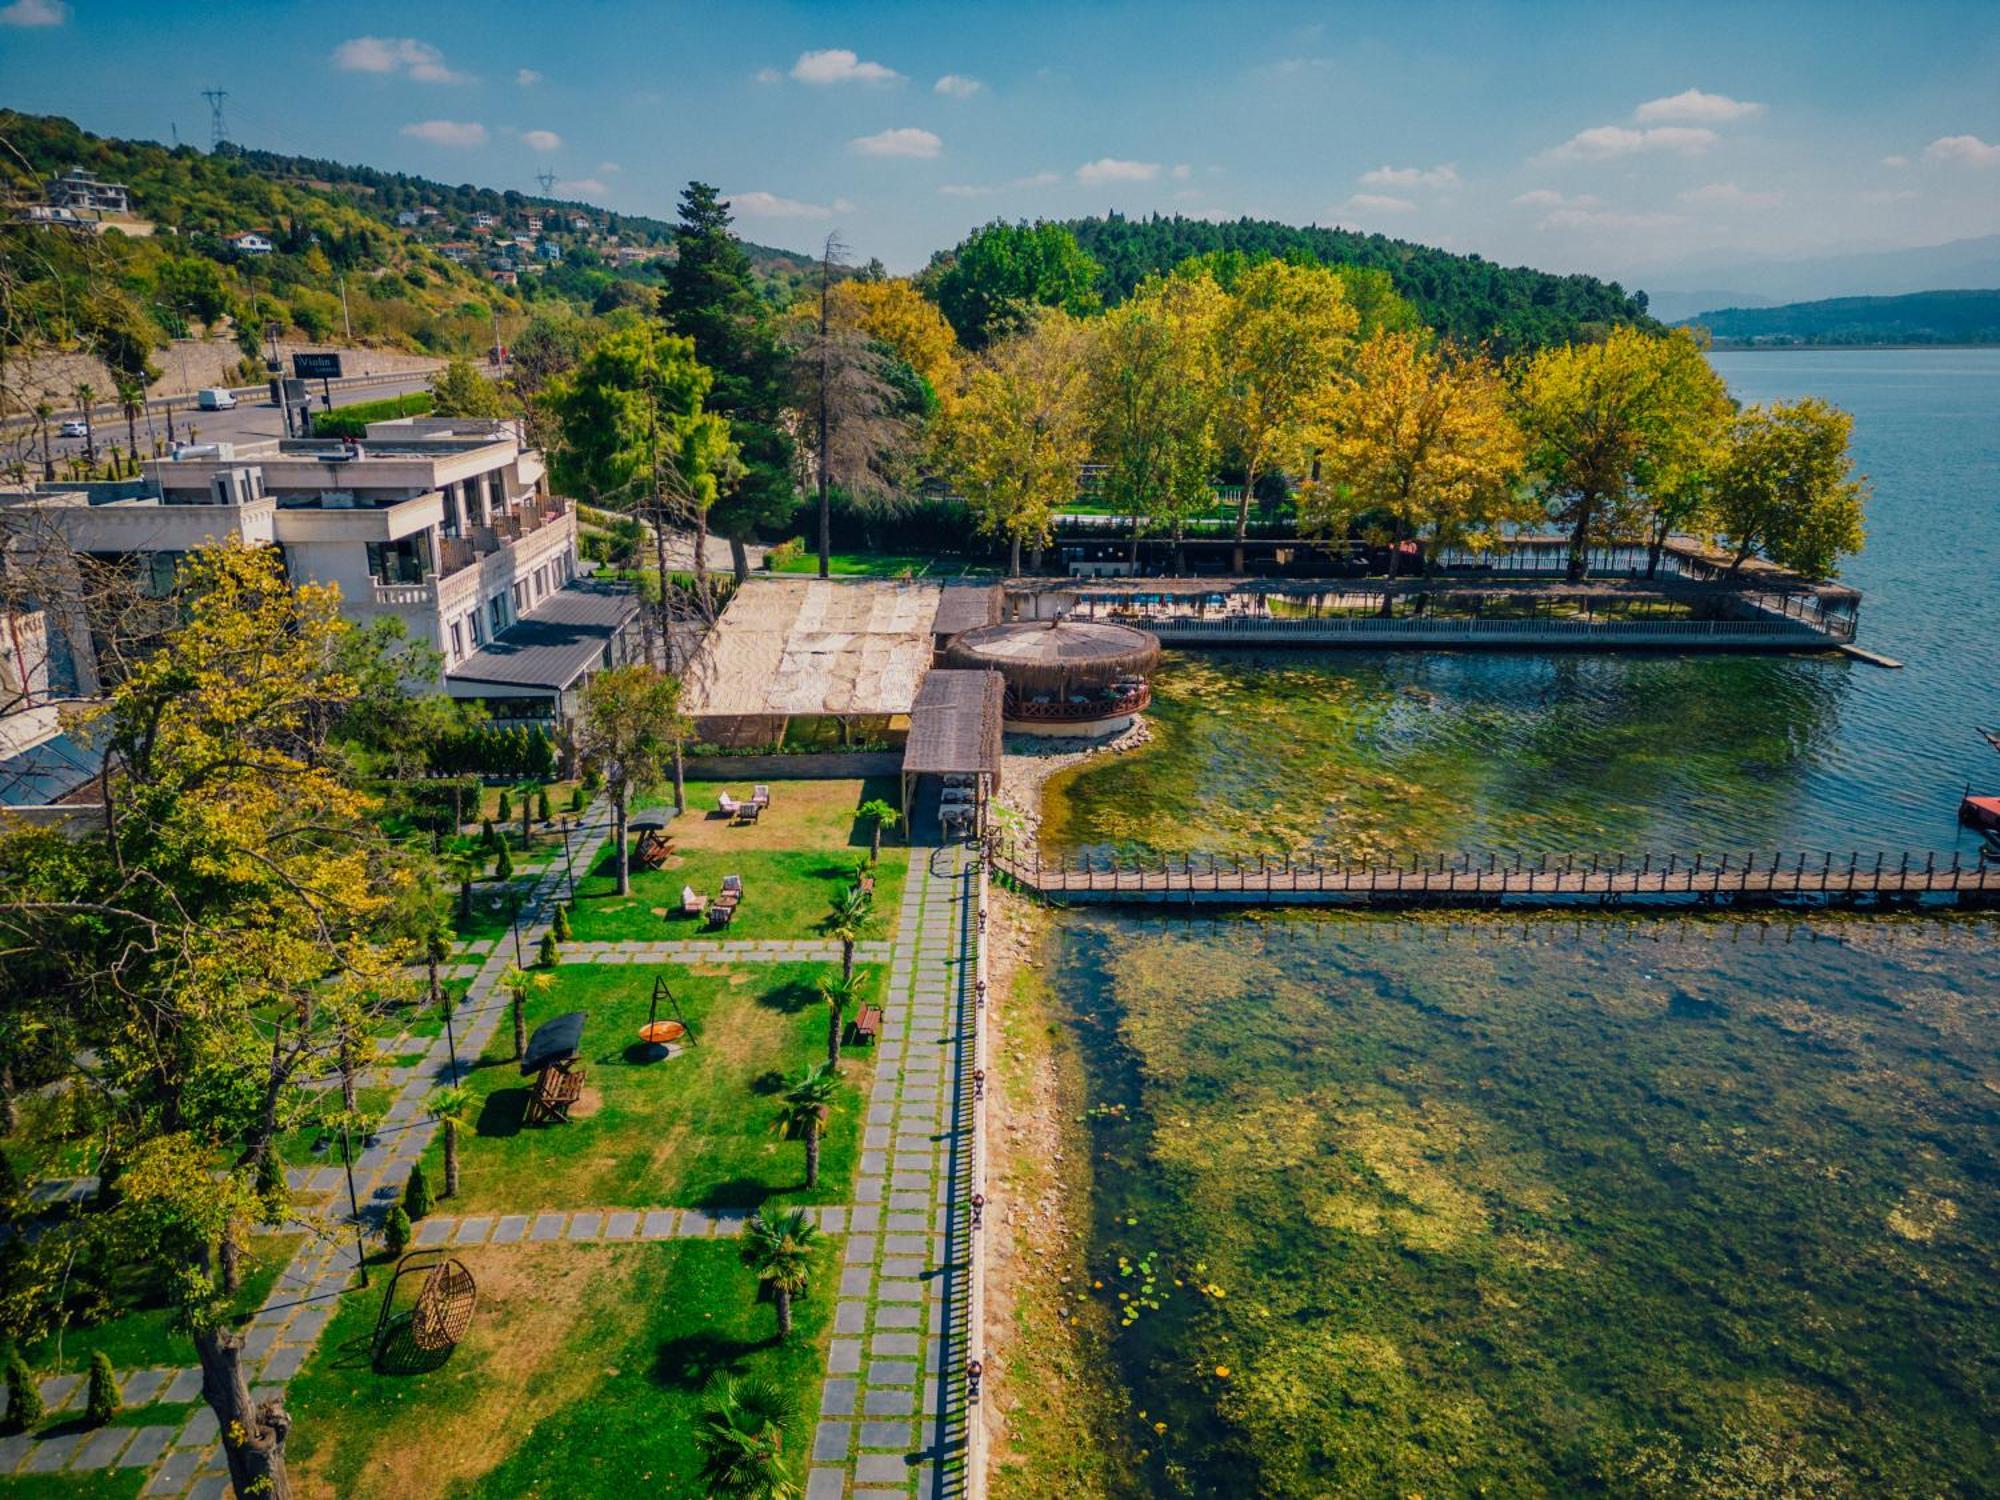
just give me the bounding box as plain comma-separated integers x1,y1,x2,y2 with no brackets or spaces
1042,350,2000,1500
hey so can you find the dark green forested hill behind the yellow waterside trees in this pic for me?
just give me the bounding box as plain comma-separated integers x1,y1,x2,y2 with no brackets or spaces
1066,214,1652,354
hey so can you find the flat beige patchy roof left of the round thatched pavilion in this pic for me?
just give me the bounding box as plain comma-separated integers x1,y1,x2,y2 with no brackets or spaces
686,576,940,718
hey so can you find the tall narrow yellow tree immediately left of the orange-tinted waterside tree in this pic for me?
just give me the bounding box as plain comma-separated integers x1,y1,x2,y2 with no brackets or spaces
1214,260,1360,572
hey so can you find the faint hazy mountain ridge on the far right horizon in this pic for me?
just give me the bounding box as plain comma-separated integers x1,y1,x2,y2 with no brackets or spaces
1646,234,2000,320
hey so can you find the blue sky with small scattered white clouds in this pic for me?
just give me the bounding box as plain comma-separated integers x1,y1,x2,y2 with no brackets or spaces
0,0,2000,286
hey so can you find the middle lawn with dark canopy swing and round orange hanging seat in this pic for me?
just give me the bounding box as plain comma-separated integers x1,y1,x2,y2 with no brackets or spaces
424,964,884,1214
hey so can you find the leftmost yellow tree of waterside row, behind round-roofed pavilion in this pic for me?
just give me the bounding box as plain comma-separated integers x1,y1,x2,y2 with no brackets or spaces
938,308,1090,574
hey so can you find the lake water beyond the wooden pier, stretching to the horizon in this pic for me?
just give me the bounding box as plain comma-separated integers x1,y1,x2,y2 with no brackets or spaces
1044,350,2000,856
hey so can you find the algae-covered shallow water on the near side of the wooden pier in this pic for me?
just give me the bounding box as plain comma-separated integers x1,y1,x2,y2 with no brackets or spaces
1056,916,2000,1496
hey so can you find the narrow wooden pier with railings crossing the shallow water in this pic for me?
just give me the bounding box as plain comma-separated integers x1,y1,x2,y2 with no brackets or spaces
988,838,2000,906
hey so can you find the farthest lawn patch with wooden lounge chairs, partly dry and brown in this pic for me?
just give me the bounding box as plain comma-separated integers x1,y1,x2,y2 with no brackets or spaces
570,778,908,942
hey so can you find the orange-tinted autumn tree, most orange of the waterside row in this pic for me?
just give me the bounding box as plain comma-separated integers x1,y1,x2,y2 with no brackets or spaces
1298,332,1524,584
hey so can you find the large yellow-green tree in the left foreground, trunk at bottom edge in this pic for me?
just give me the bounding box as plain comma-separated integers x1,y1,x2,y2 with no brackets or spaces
0,542,420,1500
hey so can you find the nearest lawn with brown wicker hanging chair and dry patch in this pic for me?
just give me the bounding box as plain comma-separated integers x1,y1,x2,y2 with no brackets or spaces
286,1240,838,1500
